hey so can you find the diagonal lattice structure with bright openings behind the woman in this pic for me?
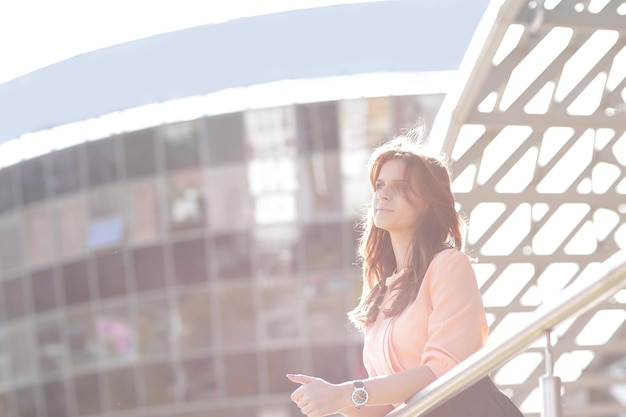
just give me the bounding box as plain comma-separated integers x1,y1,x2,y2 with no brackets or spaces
433,0,626,417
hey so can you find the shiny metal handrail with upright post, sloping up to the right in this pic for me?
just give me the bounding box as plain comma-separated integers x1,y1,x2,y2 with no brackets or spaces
386,250,626,417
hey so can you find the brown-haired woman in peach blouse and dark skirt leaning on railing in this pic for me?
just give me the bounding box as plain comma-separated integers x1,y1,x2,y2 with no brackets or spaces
287,131,521,417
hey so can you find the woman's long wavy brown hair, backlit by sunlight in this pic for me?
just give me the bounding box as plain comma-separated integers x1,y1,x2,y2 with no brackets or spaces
348,129,463,330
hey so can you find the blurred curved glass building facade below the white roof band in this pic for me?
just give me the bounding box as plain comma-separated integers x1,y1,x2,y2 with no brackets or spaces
0,94,443,417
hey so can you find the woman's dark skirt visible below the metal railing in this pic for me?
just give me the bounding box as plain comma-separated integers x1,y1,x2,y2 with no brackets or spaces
424,377,524,417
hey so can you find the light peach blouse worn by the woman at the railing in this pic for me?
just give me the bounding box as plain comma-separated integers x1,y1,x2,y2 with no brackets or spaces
363,249,488,378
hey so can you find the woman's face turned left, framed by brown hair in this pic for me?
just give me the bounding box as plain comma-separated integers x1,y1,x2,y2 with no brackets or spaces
372,159,427,234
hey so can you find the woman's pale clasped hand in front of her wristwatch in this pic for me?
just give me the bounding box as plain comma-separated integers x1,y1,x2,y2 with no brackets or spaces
287,374,350,417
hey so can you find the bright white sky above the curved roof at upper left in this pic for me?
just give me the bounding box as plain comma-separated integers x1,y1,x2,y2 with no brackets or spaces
0,0,383,84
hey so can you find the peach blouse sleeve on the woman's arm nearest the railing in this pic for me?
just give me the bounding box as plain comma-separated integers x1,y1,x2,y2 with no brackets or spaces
422,250,488,377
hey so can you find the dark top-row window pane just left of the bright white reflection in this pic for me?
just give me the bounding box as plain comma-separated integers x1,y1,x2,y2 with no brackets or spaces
206,113,244,165
